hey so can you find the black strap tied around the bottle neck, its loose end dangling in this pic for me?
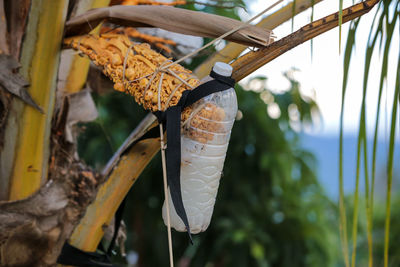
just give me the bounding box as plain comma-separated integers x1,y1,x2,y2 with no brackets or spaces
155,72,235,244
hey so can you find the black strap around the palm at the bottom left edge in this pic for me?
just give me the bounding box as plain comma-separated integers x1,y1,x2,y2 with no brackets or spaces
57,242,117,267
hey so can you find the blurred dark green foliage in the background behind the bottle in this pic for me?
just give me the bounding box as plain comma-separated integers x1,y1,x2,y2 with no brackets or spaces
79,72,339,266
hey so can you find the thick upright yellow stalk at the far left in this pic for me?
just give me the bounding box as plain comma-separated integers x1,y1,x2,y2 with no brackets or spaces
7,0,68,200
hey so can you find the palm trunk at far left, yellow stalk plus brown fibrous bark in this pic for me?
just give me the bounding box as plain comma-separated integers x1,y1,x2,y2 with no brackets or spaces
0,0,107,266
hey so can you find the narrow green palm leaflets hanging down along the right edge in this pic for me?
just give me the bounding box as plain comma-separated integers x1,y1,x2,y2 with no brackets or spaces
339,0,400,267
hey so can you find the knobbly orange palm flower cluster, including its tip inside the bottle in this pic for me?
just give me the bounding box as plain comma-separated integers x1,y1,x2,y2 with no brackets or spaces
64,33,224,143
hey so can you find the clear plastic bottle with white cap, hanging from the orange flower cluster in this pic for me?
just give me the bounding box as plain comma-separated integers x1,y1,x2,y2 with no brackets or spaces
162,62,238,234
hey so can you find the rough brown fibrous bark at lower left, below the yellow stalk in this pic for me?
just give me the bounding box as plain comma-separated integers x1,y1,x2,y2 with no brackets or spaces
0,95,102,266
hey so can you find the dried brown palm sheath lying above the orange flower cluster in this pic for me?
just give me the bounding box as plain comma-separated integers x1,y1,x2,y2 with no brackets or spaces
66,6,273,47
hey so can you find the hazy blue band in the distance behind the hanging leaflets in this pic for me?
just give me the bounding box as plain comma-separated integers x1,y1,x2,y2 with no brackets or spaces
300,134,400,200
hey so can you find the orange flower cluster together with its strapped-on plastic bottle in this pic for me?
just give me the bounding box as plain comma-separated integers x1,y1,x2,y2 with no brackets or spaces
64,34,237,239
